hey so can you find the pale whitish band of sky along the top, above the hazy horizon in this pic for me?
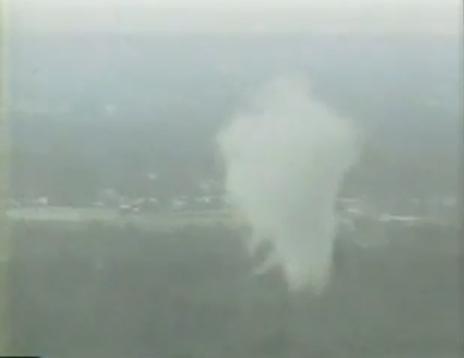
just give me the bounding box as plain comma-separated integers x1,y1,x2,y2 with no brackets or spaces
9,0,461,35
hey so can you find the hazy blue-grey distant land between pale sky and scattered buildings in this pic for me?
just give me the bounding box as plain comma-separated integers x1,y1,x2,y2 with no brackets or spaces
10,34,460,207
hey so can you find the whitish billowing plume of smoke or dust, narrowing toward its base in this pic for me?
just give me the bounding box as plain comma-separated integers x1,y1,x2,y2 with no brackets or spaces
217,78,358,291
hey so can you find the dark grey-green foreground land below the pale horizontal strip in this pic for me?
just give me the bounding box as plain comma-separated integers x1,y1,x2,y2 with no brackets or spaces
10,223,460,358
